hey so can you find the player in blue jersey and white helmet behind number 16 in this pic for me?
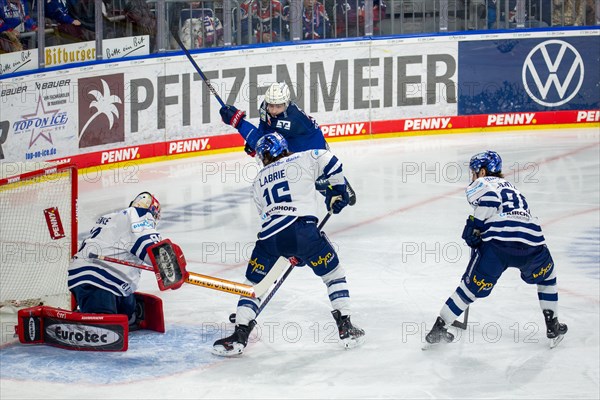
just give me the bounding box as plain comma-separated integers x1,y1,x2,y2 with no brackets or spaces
219,82,356,205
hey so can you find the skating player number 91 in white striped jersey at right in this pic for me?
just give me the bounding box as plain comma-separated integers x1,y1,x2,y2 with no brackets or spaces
425,151,567,347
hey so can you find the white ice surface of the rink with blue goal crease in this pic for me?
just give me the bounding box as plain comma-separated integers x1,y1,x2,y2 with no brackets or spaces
0,128,600,400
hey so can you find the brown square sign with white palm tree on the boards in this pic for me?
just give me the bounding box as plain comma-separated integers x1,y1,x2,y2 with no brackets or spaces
77,74,125,148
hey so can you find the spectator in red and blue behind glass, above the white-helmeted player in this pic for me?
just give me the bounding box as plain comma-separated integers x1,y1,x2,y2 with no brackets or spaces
240,0,284,43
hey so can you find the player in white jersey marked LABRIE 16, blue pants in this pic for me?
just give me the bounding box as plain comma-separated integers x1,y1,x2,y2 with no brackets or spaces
213,133,364,356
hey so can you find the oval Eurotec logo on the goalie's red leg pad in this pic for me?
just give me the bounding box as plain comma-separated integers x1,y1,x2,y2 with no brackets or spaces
44,319,124,350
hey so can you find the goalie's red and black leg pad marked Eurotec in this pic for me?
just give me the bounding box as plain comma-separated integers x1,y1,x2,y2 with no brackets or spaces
15,306,129,351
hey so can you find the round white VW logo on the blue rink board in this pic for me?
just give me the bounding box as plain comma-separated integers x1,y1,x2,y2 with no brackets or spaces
522,40,584,107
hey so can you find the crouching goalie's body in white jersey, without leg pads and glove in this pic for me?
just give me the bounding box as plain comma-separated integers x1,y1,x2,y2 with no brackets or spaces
68,192,161,324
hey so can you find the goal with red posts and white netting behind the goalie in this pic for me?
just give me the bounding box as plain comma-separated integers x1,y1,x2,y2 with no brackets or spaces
0,163,77,309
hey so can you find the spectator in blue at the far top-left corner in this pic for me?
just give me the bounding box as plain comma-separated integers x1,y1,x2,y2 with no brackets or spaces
0,0,37,53
